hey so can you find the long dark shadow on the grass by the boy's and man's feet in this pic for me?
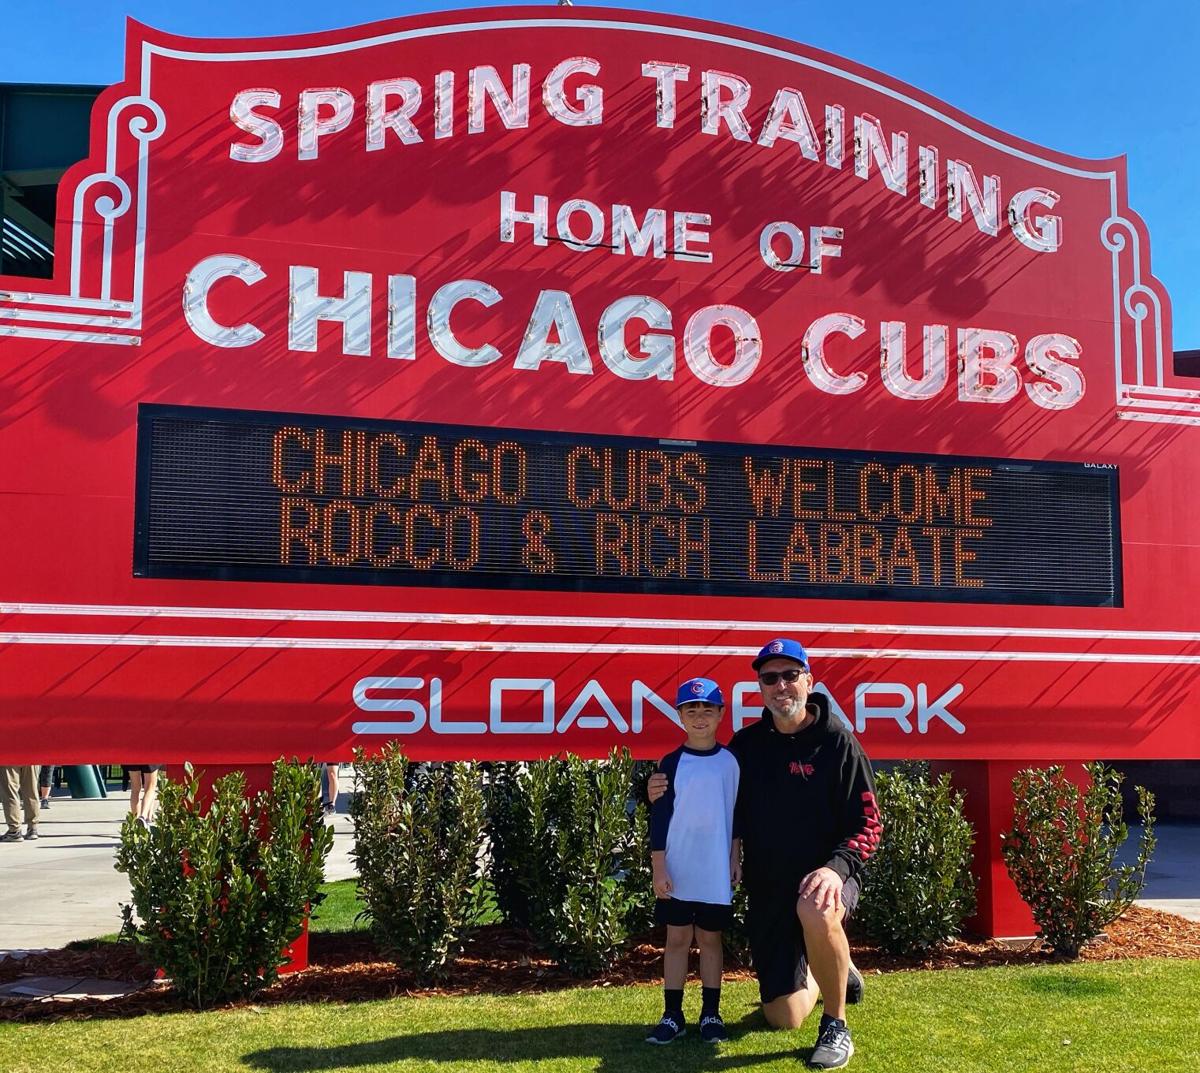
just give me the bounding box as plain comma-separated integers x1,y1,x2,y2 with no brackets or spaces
242,1021,810,1073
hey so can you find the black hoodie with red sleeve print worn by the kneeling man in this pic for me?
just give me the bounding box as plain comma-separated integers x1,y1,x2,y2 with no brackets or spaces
730,693,883,891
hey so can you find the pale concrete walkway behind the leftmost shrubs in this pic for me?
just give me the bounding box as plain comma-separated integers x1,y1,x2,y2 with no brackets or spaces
0,775,356,955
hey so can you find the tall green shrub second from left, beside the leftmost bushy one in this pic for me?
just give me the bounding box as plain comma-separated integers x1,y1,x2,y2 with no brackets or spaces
350,742,494,979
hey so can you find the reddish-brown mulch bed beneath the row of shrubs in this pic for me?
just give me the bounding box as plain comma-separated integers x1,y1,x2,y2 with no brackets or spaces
0,906,1200,1021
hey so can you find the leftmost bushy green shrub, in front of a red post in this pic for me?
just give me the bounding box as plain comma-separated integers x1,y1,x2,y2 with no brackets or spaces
116,760,334,1008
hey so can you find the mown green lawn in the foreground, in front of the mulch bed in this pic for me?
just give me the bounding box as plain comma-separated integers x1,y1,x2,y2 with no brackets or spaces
0,960,1200,1073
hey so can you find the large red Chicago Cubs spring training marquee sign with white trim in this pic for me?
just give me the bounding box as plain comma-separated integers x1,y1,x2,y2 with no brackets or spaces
0,7,1200,763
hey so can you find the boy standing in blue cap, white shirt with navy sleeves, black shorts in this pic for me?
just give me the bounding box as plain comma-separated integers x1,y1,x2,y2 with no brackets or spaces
646,678,742,1043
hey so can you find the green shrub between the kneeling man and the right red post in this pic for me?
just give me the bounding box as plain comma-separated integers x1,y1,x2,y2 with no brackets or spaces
857,763,976,954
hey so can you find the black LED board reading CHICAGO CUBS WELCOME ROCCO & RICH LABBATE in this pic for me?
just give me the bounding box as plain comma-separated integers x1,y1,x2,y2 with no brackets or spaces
134,407,1120,606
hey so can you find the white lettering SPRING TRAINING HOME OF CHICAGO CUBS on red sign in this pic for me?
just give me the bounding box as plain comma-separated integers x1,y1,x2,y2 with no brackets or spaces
177,56,1086,410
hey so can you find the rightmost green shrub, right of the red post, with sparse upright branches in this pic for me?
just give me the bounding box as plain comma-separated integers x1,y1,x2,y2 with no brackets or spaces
1001,763,1154,958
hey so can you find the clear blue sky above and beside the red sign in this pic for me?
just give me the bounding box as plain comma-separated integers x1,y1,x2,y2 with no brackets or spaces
0,0,1200,350
